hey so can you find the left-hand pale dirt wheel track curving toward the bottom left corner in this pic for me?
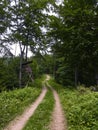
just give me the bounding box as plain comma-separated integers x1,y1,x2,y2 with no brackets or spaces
4,87,47,130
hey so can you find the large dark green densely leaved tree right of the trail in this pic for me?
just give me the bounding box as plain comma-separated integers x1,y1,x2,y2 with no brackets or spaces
49,0,98,86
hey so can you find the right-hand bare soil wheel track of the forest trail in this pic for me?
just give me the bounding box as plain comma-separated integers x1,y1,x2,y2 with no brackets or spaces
50,88,67,130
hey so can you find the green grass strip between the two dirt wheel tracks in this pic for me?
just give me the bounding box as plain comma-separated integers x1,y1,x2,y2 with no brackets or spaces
23,90,54,130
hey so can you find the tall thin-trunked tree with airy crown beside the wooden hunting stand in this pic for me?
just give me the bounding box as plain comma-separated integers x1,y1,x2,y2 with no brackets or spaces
9,0,52,87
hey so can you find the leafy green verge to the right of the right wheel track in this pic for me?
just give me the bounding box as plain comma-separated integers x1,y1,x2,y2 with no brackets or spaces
50,80,98,130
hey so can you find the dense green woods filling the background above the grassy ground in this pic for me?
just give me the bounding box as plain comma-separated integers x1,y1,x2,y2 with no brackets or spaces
0,0,98,91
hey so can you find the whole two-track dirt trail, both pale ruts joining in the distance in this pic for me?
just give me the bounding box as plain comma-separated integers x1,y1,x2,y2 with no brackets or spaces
4,75,67,130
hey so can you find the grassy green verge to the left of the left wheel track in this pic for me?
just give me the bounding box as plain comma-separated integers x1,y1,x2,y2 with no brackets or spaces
0,78,44,130
